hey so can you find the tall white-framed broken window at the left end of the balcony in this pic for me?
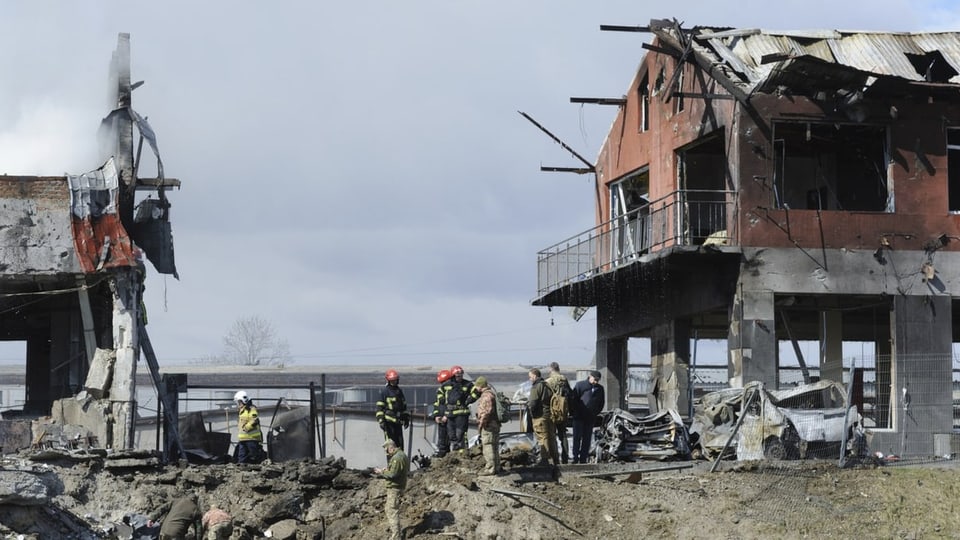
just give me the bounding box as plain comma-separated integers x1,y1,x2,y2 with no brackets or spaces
610,167,650,263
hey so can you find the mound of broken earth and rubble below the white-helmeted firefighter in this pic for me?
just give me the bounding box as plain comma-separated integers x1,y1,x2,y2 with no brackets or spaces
0,449,346,540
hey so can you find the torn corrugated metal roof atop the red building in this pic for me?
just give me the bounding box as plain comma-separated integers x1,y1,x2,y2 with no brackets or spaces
649,20,960,96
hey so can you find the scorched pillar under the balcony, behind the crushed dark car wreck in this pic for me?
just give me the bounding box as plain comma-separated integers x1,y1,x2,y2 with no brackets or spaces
650,320,690,414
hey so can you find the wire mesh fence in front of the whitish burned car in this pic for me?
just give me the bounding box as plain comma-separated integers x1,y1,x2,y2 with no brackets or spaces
627,355,960,465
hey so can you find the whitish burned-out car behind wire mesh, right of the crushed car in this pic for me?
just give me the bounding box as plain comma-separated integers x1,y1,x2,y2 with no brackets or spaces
690,380,861,460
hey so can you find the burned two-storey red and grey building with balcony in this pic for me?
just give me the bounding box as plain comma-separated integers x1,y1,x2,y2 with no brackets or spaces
533,20,960,455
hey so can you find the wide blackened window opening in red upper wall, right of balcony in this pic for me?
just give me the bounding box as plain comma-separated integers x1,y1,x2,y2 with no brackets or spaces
773,122,893,212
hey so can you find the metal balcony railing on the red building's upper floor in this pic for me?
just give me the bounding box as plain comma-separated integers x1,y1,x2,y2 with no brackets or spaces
537,190,736,297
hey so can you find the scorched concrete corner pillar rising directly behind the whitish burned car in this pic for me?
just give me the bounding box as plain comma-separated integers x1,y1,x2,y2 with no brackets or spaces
727,287,778,388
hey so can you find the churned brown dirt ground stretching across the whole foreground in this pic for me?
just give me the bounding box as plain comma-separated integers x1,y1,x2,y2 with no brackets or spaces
0,453,960,540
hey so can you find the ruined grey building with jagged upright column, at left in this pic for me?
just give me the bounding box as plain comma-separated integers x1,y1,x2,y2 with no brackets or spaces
0,34,180,449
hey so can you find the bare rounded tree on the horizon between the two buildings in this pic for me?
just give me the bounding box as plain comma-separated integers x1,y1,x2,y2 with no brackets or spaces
223,315,290,367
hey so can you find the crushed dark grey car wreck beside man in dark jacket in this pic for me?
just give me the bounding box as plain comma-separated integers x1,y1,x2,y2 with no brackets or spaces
593,409,690,462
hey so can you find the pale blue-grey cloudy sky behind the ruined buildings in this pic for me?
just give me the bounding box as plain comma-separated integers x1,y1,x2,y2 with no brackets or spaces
0,0,960,368
